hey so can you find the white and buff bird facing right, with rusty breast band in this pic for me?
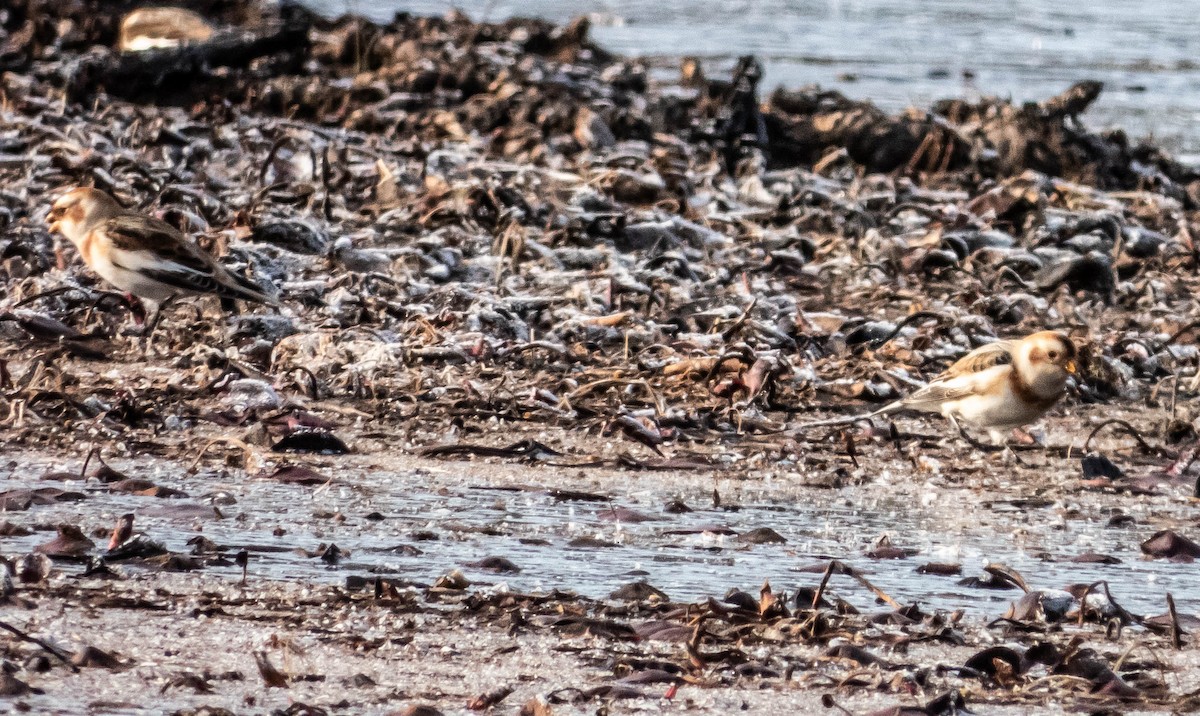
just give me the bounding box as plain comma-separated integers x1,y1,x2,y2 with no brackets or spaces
798,331,1078,443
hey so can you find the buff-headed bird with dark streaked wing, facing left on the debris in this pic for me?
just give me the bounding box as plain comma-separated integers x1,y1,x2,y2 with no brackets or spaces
47,187,278,306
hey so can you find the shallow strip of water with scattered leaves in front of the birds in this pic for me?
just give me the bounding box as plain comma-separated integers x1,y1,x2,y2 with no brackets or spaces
7,459,1200,619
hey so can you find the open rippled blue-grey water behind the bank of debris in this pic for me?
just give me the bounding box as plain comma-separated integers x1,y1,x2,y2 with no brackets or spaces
305,0,1200,161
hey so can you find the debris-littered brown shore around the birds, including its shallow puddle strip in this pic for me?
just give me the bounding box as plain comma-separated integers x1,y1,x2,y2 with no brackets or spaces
0,1,1200,714
